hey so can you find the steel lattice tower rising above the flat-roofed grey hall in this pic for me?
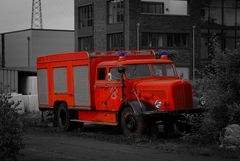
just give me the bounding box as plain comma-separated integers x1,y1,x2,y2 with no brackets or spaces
31,0,43,29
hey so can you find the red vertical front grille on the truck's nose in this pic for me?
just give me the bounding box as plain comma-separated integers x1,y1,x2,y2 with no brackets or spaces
173,84,193,110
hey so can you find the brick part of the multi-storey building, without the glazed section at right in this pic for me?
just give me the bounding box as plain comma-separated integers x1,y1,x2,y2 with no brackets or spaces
75,0,200,79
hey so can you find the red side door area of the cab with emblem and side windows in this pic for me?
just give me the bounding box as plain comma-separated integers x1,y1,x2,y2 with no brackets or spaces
95,67,122,111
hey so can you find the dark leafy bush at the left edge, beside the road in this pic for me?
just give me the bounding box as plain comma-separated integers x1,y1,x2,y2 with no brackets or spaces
0,94,24,161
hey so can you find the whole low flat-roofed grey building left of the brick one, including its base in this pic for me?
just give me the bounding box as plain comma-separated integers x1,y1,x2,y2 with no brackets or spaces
0,29,74,94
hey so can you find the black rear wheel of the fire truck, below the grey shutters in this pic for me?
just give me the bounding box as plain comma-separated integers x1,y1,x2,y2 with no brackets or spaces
56,103,72,131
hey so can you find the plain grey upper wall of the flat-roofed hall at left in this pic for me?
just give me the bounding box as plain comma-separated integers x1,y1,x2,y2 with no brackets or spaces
5,30,74,67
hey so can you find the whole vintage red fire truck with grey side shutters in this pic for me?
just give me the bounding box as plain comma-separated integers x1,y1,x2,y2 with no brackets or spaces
37,51,202,135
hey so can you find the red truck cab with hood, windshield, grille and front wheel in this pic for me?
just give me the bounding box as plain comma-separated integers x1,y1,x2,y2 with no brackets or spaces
95,53,195,134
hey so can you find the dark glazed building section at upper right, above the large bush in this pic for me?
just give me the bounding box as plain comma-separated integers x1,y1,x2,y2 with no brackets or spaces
200,0,240,64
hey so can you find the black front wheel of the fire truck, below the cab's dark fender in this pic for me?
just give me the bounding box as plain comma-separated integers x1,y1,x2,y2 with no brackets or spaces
121,107,146,136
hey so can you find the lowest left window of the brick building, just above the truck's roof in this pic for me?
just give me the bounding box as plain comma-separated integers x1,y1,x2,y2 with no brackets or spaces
78,37,93,51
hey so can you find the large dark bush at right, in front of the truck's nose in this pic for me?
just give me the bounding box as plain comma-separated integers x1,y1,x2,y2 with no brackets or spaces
190,38,240,143
